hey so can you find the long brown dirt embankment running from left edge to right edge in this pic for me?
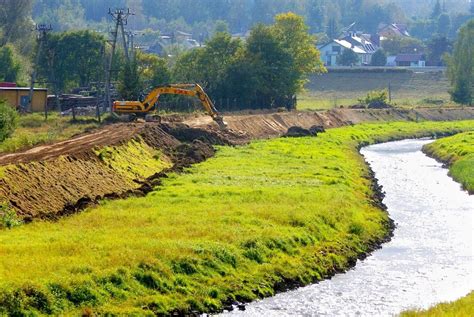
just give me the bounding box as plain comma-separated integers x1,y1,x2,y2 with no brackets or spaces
0,108,474,221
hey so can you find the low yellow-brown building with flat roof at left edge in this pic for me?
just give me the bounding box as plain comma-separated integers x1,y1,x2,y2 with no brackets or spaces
0,87,48,112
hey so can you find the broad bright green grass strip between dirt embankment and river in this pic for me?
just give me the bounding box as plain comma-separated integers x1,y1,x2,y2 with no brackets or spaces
0,121,474,315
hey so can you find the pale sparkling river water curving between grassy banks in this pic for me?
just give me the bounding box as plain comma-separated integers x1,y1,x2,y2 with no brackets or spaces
223,140,474,317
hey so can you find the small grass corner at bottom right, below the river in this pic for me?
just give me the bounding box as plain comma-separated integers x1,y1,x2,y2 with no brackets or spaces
401,292,474,317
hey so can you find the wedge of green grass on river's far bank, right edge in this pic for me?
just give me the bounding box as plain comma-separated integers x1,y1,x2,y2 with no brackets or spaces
423,132,474,193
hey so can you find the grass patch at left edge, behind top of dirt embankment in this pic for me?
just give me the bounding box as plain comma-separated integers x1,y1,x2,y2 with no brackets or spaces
0,113,99,153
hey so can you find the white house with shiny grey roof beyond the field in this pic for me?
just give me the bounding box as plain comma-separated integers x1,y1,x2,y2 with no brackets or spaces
318,33,378,66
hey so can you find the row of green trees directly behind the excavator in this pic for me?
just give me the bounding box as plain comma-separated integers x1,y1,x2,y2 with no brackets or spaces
120,13,325,110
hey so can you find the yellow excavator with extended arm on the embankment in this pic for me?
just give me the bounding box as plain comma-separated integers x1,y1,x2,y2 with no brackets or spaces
112,84,227,130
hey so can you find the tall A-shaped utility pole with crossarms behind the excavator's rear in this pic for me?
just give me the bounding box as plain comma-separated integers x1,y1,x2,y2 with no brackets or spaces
105,8,133,112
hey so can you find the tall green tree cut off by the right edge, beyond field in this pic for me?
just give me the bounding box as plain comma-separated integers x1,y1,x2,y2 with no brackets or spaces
448,20,474,105
